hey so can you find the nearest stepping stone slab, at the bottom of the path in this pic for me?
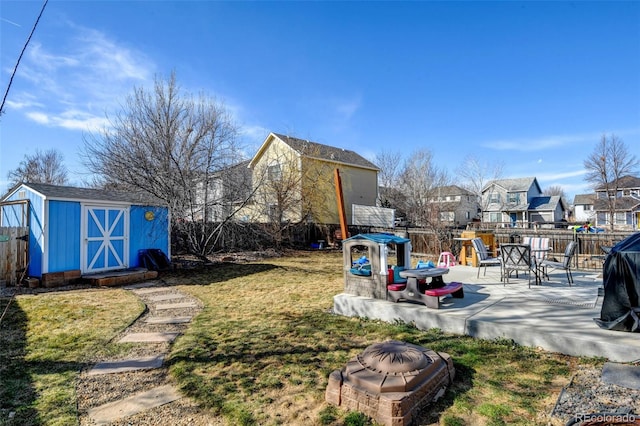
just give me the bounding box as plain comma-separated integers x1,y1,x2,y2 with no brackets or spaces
89,385,182,425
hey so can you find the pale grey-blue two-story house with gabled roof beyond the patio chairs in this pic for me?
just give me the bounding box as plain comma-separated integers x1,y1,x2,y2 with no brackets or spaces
482,177,567,227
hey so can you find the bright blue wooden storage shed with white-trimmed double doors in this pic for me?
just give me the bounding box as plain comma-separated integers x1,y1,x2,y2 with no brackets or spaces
0,183,171,277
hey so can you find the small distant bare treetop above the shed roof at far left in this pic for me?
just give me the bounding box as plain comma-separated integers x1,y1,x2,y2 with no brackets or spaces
7,149,68,185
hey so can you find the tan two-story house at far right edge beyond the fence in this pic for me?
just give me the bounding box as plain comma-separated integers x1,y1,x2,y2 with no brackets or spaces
594,176,640,230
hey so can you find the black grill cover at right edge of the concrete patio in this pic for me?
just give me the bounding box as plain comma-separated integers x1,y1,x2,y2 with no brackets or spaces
594,232,640,332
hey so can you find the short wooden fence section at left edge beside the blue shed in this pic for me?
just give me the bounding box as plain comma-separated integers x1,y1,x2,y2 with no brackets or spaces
0,226,29,286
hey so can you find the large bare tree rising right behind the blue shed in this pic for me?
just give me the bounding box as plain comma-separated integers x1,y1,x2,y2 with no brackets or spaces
83,73,242,256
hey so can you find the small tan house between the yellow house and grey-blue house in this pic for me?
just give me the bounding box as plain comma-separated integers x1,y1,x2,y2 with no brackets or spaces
429,185,480,228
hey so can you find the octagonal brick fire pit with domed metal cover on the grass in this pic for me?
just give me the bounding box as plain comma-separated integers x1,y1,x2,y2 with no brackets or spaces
325,340,455,426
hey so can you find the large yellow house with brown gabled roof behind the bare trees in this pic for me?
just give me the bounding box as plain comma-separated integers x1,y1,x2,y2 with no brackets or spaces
240,133,379,224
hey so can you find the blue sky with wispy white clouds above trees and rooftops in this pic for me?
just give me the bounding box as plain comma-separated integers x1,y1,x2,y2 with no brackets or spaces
0,0,640,201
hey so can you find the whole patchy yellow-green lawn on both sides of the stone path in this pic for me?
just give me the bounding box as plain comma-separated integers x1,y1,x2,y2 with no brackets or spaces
0,252,602,426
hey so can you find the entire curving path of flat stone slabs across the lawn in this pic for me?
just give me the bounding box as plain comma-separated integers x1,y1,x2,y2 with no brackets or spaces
84,282,199,425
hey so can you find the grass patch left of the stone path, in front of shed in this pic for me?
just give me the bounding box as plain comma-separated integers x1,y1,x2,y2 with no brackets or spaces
0,290,144,426
